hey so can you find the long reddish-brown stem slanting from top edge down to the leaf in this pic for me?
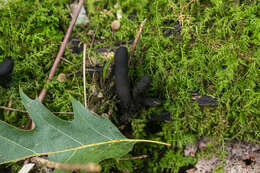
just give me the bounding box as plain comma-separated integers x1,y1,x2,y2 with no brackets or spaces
39,0,84,102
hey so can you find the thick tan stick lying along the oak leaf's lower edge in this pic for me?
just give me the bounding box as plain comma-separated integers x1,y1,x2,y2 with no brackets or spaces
31,157,101,172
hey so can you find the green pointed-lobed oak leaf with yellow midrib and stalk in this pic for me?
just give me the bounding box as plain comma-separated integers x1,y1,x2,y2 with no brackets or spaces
0,90,170,171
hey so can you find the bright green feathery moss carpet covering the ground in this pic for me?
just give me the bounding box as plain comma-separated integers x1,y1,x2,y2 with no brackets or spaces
0,0,260,172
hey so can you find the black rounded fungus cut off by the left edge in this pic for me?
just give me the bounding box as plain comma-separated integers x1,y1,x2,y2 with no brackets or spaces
0,58,14,88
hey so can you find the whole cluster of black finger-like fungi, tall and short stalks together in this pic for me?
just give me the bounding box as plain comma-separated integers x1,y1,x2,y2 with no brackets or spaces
114,47,168,123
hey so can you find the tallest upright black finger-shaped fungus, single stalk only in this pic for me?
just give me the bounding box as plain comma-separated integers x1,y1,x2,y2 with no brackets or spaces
114,47,132,112
